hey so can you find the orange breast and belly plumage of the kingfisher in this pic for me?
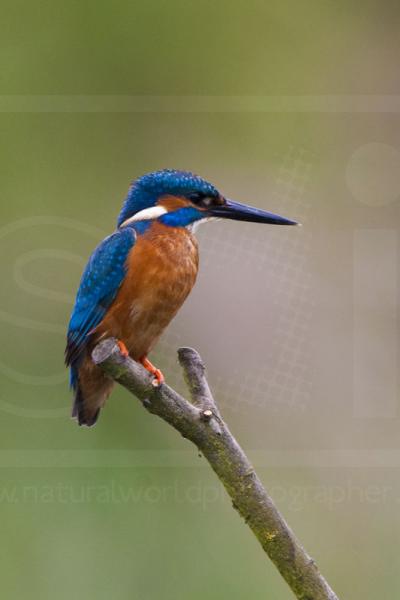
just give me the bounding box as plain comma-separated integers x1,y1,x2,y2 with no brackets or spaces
96,223,198,360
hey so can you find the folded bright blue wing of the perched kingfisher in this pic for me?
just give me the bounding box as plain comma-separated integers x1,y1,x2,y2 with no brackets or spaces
65,228,136,386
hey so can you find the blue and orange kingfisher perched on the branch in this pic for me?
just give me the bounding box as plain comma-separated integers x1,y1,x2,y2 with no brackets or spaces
65,169,298,427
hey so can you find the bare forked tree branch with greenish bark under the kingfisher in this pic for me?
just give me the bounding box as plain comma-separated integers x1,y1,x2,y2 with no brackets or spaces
92,339,338,600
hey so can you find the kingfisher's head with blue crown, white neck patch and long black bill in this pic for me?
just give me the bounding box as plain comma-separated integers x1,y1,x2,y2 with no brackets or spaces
118,170,297,232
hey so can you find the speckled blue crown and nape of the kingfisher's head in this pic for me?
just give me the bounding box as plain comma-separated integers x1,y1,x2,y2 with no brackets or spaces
118,169,218,227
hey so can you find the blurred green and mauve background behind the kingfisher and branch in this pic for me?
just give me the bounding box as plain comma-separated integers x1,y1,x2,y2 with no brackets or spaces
0,0,400,600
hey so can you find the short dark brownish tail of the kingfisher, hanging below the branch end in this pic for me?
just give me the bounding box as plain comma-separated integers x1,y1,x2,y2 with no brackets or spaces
71,359,113,427
